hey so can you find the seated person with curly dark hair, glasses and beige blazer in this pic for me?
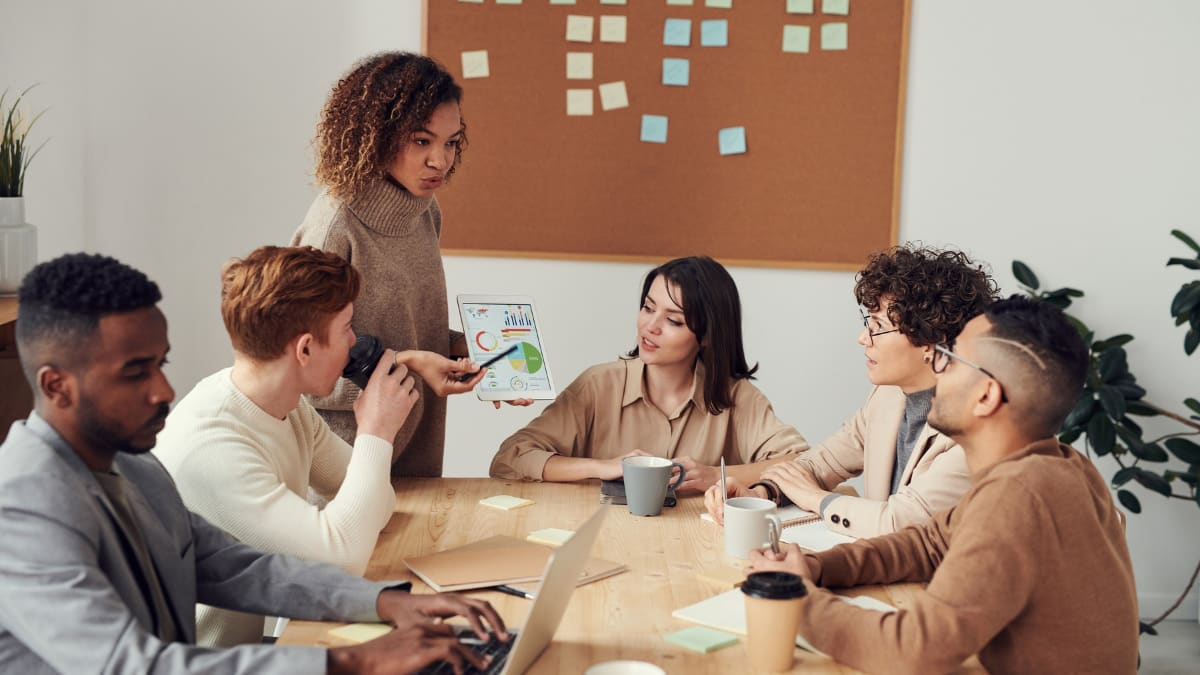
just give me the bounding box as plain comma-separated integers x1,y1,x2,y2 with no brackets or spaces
704,245,997,537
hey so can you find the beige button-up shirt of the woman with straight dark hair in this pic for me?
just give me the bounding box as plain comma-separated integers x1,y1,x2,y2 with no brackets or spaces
491,358,809,480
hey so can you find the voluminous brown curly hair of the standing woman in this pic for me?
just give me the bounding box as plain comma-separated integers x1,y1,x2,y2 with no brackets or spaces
313,52,467,201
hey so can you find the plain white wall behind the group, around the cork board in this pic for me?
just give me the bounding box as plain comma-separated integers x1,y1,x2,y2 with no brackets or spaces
0,0,1200,617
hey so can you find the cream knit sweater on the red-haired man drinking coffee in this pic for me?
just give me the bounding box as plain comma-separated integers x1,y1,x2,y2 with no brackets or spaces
155,369,396,646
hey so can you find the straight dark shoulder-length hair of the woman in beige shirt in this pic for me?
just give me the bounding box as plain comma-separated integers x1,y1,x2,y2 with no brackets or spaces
629,256,758,414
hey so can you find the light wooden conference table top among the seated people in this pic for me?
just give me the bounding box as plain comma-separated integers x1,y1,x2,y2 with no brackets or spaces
278,478,983,675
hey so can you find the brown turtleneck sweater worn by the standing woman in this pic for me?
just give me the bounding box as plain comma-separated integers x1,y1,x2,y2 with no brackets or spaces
292,180,460,476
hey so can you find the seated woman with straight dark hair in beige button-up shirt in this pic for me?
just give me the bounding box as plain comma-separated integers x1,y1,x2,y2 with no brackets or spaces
491,257,809,490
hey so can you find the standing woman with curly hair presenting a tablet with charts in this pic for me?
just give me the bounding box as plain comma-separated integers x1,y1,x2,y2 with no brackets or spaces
292,52,492,476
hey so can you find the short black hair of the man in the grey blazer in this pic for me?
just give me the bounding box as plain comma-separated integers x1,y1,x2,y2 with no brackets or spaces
17,253,162,392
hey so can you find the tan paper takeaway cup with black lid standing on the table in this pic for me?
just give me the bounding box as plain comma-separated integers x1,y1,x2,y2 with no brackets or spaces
742,572,805,673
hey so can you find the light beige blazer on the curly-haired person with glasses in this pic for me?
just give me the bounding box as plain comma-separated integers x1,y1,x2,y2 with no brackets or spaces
794,387,971,537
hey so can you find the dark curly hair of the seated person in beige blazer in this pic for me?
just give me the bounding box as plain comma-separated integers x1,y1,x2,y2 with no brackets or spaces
854,244,998,347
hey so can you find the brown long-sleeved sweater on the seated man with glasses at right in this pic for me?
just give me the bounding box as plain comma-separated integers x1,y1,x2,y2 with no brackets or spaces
800,438,1138,675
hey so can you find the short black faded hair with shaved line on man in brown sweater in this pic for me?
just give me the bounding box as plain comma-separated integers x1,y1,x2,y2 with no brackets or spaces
984,295,1091,436
